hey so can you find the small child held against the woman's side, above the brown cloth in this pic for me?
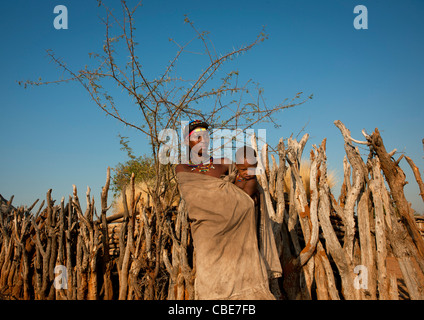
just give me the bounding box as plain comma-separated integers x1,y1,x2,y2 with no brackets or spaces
234,146,258,200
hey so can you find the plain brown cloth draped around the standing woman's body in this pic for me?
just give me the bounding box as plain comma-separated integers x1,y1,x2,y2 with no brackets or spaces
177,165,281,300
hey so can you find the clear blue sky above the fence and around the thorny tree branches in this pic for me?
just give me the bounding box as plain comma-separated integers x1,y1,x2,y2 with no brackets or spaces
0,0,424,212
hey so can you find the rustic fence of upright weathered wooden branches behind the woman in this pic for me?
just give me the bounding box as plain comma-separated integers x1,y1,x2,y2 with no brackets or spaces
0,121,424,300
